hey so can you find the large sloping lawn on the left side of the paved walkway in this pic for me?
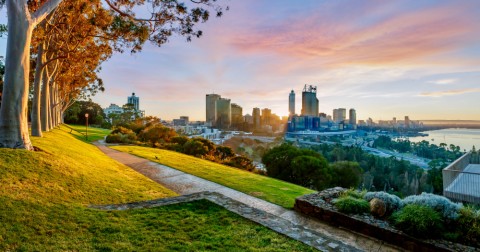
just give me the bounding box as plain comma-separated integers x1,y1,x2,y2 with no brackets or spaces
0,126,312,251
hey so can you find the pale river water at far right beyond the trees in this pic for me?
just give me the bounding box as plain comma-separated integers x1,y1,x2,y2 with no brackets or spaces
409,128,480,151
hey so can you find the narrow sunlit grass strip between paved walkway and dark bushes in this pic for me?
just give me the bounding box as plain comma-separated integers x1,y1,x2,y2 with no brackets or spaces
112,146,314,208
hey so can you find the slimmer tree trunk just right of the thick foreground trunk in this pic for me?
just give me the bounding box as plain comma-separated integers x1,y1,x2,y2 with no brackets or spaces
32,43,44,137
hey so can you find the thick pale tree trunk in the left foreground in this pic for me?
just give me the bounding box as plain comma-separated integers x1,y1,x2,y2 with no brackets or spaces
0,0,33,150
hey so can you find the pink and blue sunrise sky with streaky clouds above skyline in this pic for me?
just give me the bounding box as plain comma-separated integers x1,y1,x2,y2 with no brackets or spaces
0,0,480,120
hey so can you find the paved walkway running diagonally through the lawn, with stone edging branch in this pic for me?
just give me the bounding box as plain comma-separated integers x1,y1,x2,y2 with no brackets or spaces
96,143,398,251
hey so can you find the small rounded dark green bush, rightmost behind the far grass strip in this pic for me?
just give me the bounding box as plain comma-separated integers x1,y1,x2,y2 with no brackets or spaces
330,161,362,188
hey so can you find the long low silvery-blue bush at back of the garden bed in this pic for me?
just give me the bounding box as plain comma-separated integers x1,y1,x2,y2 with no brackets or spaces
403,192,462,220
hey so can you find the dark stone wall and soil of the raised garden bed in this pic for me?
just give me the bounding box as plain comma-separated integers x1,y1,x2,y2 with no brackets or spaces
294,187,478,251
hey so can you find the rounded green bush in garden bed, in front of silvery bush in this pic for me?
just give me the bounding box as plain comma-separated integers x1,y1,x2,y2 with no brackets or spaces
391,205,443,238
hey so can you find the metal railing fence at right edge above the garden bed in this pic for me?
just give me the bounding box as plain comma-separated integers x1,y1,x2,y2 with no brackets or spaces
442,153,480,204
